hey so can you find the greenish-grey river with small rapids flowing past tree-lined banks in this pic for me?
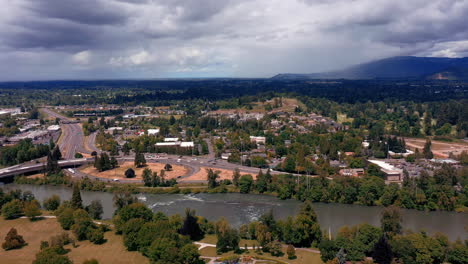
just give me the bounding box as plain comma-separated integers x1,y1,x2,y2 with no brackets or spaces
2,184,468,240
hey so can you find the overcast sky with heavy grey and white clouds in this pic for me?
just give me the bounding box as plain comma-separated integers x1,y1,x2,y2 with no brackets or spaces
0,0,468,80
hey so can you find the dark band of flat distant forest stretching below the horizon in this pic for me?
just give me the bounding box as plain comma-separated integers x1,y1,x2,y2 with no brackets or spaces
0,79,468,105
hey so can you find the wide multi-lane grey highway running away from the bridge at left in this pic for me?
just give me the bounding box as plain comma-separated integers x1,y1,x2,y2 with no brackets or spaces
41,108,97,159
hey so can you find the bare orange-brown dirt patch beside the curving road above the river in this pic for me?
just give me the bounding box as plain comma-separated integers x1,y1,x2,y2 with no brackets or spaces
81,161,188,181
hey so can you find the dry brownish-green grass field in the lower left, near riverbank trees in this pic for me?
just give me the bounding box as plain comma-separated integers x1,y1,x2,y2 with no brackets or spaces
0,217,149,264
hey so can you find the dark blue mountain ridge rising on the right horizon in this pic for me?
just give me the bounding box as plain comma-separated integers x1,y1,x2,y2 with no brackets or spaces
272,56,468,80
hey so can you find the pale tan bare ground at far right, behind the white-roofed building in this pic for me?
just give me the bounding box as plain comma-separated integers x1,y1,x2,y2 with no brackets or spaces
405,138,468,158
